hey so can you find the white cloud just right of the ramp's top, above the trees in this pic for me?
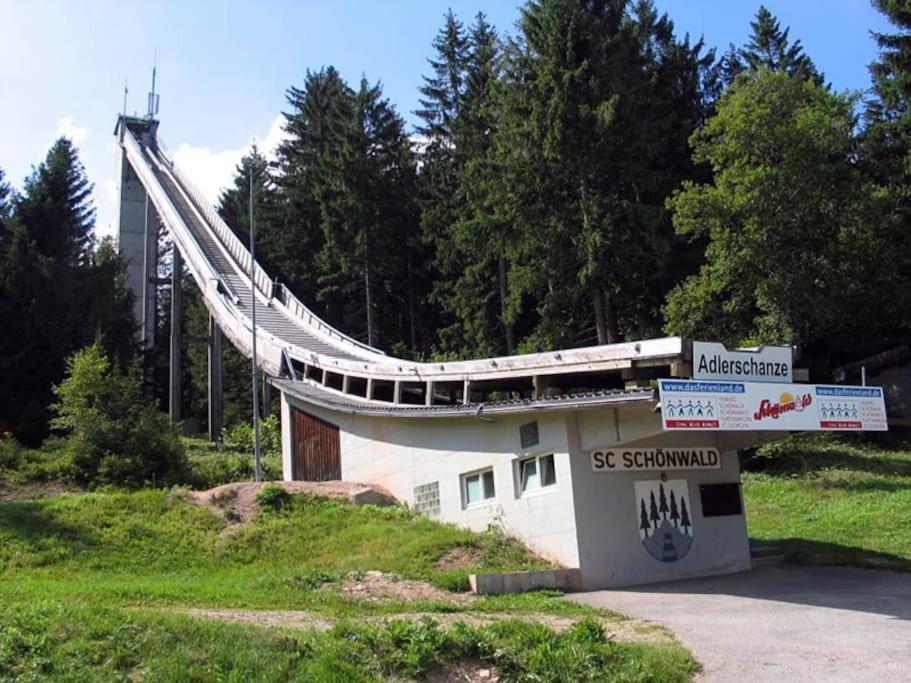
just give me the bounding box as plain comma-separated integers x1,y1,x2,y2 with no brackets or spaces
173,115,287,204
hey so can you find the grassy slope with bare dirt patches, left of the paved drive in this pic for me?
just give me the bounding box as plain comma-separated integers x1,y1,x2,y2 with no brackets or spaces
0,491,693,681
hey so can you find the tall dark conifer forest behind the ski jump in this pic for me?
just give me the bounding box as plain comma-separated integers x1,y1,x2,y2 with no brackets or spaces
0,0,911,444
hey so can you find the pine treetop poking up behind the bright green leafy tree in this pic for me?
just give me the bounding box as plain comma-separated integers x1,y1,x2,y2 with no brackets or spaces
739,5,824,85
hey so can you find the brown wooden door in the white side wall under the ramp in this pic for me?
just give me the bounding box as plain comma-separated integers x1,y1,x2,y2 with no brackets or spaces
291,408,342,481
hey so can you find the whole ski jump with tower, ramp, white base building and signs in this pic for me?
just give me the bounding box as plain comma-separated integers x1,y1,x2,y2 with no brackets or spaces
116,109,886,588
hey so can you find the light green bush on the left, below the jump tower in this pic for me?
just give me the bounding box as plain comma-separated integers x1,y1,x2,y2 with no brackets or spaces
51,342,185,487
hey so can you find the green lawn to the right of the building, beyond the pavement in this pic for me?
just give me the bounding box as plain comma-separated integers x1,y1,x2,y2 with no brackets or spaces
743,434,911,571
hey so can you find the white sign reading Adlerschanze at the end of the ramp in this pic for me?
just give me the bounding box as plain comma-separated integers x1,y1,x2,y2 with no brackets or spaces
693,341,794,383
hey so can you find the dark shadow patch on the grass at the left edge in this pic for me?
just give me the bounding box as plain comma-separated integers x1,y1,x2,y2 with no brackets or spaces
0,501,99,562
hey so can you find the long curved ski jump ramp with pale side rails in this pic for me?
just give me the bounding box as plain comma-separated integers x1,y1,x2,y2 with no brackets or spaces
117,117,685,415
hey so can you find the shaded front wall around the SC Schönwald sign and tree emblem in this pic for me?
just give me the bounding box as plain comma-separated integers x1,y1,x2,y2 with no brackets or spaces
569,407,750,588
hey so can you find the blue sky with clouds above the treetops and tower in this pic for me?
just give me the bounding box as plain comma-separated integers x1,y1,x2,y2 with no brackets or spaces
0,0,888,240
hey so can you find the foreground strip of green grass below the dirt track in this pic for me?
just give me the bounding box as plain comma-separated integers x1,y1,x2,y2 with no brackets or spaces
0,603,693,682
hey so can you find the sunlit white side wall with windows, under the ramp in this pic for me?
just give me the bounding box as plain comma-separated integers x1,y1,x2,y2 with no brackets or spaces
282,393,579,567
